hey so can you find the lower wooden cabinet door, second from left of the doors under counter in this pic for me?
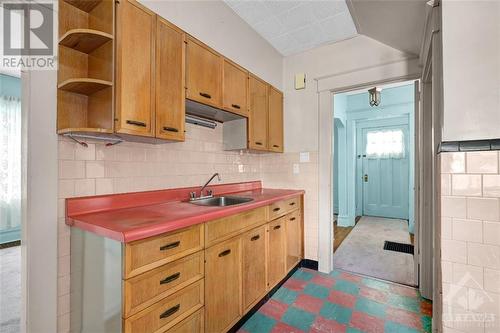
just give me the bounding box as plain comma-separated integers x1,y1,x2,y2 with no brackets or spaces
242,225,267,311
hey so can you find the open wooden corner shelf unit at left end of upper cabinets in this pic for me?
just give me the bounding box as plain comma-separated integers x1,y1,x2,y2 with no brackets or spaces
57,0,115,134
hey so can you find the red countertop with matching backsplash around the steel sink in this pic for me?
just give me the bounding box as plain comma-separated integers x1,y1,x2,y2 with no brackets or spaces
66,182,304,243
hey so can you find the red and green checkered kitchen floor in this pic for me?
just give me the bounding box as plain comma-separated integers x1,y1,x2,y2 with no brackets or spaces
239,268,432,333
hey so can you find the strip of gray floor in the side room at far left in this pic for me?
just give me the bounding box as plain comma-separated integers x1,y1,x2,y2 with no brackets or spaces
0,246,21,333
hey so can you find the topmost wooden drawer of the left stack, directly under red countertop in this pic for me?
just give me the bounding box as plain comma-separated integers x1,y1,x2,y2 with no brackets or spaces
125,224,203,279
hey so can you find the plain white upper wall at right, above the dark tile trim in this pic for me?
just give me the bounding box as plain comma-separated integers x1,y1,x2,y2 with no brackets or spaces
442,0,500,141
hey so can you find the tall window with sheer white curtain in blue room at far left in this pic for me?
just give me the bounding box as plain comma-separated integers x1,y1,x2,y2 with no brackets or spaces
0,75,21,243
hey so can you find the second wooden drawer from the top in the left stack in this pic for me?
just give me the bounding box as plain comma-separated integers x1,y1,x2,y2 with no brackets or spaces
123,251,204,318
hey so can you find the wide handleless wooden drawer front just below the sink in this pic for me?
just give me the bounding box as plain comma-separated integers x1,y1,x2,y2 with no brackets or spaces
205,207,266,247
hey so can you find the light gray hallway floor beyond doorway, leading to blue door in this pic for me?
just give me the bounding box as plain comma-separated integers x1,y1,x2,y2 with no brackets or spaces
333,216,415,285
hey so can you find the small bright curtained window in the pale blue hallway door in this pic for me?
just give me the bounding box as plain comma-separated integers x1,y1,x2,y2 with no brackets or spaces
366,129,405,158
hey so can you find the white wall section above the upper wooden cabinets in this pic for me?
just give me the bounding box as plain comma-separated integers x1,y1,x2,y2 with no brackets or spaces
140,0,283,89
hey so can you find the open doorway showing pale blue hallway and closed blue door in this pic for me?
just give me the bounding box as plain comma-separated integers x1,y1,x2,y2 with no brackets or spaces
332,81,418,286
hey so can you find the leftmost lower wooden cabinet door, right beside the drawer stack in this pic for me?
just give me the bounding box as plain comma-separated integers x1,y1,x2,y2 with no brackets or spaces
205,238,241,333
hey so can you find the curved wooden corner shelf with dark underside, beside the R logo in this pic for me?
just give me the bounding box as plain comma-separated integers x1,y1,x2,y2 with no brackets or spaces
59,29,113,54
